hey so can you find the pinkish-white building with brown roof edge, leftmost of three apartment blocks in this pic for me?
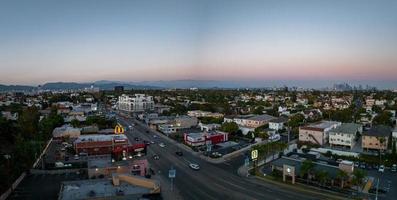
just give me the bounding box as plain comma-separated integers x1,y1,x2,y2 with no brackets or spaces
299,121,342,145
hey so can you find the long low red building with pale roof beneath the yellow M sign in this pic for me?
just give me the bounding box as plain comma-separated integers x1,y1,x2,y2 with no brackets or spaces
74,134,128,155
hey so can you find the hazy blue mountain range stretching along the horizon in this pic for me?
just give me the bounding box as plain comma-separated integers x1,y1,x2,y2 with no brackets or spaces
0,80,397,92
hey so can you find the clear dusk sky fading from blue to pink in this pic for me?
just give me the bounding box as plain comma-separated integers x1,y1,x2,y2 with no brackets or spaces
0,0,397,84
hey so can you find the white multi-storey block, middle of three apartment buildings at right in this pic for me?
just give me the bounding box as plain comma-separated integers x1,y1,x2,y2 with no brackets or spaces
329,123,363,149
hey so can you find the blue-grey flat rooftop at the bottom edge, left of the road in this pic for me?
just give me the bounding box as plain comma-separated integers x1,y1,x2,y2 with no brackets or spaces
59,179,150,200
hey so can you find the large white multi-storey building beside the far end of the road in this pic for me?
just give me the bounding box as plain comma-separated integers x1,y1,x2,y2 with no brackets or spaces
118,94,154,112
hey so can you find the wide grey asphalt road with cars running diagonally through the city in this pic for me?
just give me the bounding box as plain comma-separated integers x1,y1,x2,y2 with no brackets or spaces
119,115,344,200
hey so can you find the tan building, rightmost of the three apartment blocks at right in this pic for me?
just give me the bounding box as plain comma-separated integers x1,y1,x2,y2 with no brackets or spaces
362,125,391,151
